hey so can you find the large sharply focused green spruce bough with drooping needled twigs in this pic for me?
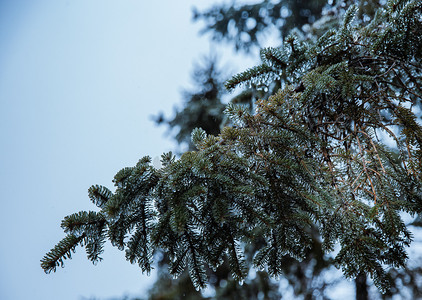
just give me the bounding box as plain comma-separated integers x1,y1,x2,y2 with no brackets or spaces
42,0,422,298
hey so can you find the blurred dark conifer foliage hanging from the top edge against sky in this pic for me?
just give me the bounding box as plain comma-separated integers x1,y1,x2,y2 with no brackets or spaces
194,0,327,51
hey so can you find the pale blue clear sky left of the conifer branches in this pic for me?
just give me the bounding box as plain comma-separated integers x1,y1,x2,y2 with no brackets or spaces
0,0,258,300
